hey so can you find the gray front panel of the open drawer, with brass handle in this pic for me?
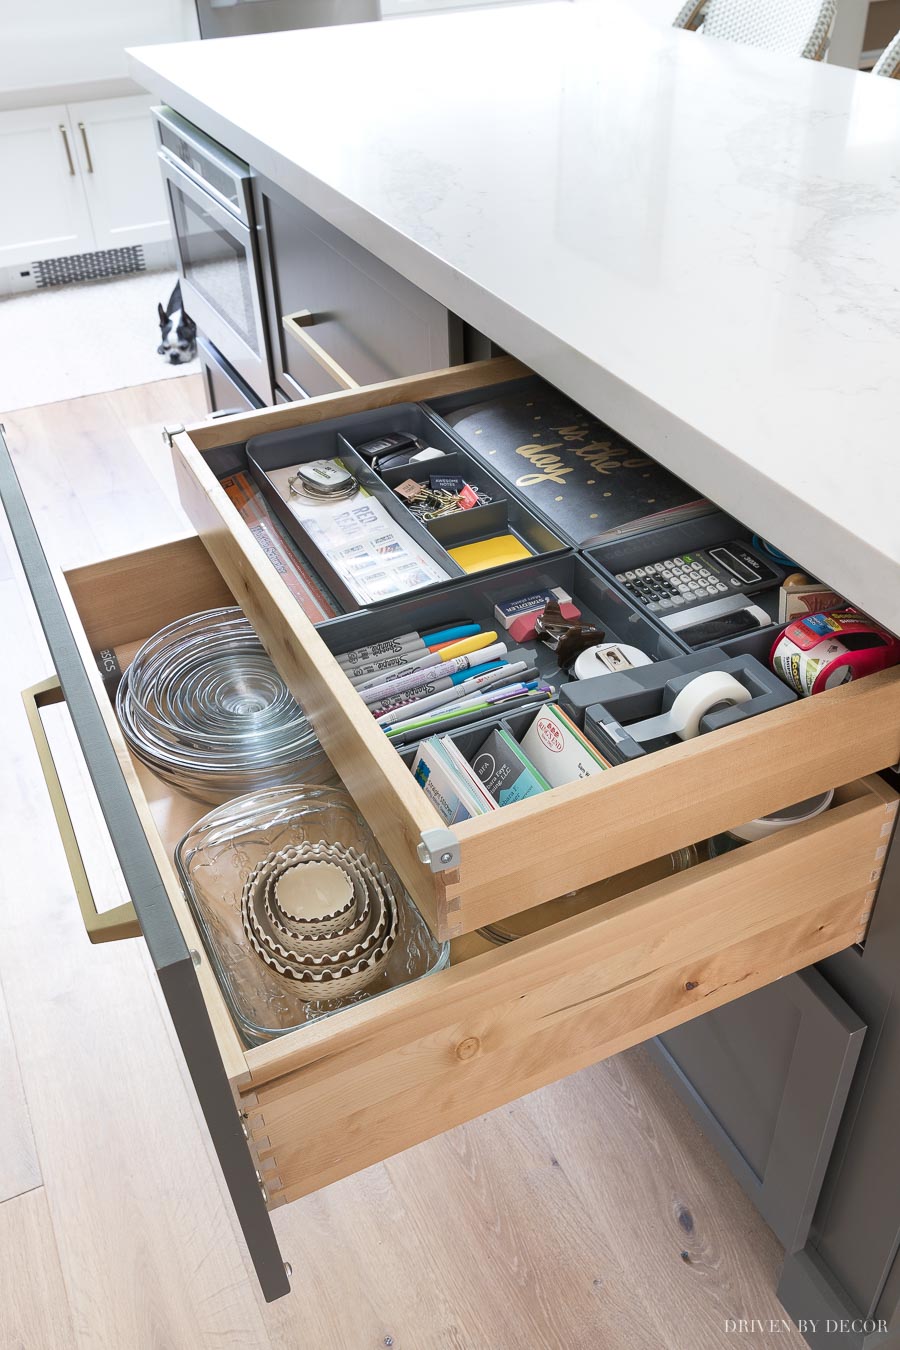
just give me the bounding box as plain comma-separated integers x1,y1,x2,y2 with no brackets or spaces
0,436,290,1300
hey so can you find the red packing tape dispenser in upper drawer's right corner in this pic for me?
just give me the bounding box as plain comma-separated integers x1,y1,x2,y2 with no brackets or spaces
769,609,900,695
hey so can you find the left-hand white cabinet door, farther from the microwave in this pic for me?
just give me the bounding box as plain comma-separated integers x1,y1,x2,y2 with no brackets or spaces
0,105,93,267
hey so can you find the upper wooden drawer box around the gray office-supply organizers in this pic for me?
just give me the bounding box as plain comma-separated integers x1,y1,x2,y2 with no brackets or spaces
174,358,900,938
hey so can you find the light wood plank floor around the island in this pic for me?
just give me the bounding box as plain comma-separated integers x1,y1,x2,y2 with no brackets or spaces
0,377,804,1350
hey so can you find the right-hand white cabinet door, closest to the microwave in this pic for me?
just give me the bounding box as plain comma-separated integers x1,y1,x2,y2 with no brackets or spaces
69,95,170,248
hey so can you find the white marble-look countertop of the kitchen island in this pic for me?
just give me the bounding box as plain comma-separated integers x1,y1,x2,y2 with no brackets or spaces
132,0,900,633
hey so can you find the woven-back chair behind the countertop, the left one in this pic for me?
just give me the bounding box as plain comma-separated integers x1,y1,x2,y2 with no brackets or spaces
675,0,837,61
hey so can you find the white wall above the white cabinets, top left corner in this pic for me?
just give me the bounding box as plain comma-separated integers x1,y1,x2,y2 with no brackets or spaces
0,0,197,93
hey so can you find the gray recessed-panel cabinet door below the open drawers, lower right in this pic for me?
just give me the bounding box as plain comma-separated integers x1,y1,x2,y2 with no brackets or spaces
653,968,865,1251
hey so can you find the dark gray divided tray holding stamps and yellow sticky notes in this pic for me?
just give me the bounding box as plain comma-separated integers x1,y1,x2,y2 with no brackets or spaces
247,404,567,612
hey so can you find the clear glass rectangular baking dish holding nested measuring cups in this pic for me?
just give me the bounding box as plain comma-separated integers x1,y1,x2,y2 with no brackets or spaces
175,784,449,1045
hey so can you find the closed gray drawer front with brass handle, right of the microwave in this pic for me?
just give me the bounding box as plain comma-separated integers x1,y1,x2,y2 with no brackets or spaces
254,178,461,397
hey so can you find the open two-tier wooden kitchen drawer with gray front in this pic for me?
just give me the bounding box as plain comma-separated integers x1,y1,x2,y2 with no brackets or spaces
0,369,900,1299
